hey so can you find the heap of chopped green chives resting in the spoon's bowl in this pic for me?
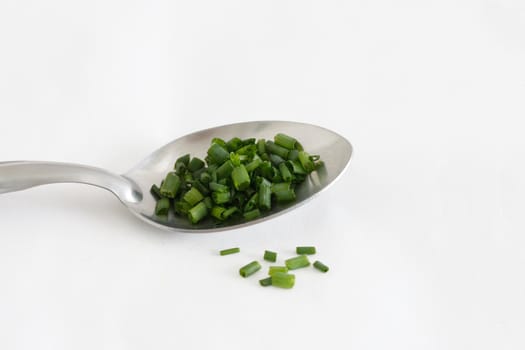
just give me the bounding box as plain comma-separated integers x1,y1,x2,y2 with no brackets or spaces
150,133,322,224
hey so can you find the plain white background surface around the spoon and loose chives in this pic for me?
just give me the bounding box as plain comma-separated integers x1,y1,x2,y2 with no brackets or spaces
0,0,525,350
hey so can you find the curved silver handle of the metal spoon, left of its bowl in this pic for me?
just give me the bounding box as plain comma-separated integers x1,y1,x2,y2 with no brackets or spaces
0,161,142,203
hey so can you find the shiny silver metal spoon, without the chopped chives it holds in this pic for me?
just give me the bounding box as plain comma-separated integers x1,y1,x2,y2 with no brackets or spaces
0,121,352,232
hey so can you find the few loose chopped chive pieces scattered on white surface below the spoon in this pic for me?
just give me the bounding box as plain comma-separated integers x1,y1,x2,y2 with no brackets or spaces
219,246,329,289
